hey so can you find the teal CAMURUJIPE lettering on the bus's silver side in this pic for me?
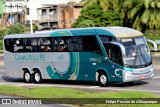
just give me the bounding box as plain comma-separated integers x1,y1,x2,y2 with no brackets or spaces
15,54,45,61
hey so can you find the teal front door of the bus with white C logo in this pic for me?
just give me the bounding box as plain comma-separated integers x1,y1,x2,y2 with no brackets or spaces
106,42,123,82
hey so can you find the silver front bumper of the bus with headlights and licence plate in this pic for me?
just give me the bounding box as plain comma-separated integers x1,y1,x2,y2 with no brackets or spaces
123,65,154,82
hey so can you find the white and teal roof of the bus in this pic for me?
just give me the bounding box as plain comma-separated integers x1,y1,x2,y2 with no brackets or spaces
4,27,143,38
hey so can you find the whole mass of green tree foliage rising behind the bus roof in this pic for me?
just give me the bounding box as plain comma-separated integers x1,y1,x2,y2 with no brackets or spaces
73,0,160,32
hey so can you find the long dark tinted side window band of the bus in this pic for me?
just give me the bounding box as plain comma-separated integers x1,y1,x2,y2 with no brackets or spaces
5,36,101,53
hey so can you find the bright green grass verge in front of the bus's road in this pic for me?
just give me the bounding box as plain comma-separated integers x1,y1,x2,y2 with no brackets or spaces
0,85,160,107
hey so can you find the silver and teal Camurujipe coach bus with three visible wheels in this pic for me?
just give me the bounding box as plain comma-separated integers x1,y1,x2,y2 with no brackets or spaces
3,27,153,86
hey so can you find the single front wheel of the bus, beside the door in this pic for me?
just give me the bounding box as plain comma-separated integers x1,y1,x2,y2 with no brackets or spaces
98,73,109,87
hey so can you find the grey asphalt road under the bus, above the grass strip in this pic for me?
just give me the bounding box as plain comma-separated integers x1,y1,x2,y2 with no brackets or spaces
0,56,160,97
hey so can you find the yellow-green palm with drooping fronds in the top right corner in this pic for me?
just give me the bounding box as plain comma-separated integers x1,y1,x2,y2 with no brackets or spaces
121,0,160,31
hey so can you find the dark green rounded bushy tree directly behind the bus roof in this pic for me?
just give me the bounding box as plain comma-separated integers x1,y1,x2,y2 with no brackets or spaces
72,3,122,27
